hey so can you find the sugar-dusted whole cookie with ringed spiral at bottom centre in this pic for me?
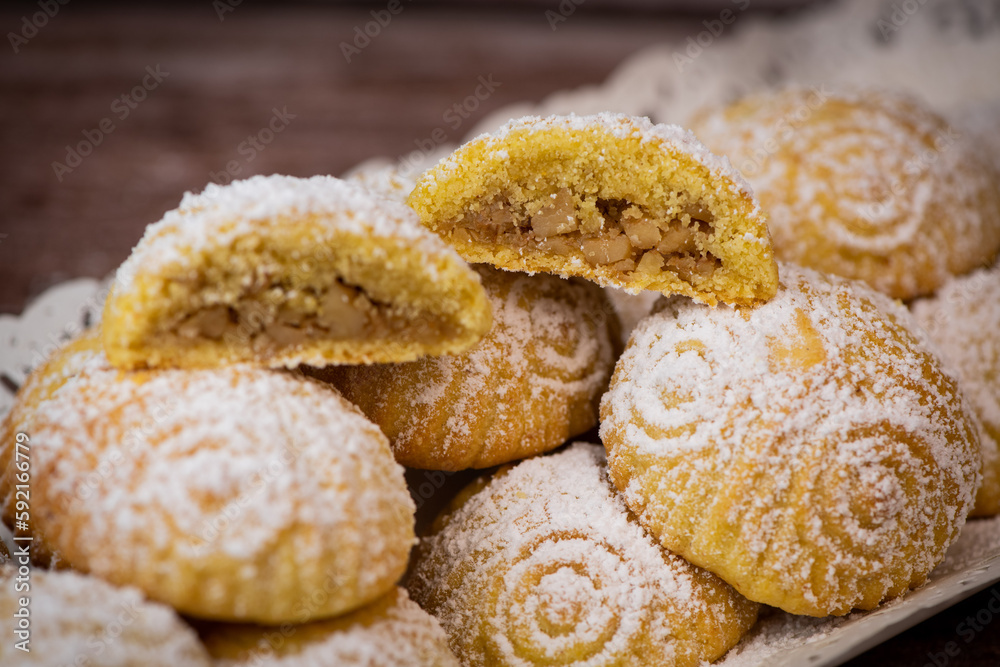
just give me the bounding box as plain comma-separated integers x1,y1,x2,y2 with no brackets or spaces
407,443,758,667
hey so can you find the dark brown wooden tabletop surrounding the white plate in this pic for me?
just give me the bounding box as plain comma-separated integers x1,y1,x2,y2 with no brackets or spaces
0,6,1000,667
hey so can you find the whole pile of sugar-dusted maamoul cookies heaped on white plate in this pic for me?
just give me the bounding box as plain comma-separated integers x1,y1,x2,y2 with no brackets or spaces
0,90,1000,666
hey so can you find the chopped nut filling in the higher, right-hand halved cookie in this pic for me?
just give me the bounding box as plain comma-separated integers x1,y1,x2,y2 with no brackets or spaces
446,188,721,282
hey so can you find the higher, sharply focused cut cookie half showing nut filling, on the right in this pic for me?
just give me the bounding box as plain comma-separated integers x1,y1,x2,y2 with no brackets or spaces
407,113,777,304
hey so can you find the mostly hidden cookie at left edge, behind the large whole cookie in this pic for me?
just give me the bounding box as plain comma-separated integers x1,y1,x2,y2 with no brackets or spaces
0,329,107,567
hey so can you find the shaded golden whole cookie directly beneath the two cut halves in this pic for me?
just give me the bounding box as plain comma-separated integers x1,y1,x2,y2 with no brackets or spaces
318,265,621,470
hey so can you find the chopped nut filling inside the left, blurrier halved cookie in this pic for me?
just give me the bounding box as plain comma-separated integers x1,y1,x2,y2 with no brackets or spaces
157,279,453,352
